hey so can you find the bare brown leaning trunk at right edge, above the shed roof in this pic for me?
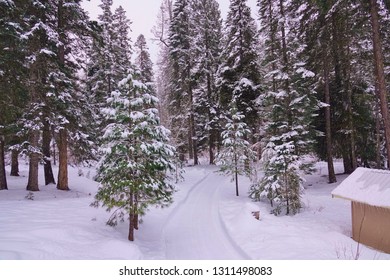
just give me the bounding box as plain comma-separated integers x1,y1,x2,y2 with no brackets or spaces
370,0,390,168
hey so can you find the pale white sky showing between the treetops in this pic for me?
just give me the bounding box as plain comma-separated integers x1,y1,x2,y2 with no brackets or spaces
82,0,258,64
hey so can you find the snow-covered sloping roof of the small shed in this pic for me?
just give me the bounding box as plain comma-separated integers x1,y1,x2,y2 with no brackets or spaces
332,167,390,208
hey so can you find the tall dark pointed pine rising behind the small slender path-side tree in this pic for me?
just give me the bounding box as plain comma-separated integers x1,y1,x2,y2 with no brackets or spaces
217,0,262,137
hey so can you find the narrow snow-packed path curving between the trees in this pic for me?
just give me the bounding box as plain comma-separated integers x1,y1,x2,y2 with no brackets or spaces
163,167,248,259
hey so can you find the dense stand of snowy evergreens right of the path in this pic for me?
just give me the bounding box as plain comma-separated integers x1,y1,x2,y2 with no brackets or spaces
157,0,390,214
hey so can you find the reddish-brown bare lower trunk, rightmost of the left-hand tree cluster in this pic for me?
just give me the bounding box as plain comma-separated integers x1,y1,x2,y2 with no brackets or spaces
57,128,69,191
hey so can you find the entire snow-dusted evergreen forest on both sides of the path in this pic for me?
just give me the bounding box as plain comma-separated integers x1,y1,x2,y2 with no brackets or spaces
0,0,390,240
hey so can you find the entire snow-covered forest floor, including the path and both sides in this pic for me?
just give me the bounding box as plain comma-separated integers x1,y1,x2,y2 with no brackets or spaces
0,160,390,260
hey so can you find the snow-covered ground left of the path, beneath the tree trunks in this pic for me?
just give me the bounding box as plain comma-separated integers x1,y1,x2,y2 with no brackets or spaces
0,166,142,259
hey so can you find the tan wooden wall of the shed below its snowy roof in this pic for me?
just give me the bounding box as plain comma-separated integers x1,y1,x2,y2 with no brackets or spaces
352,201,390,254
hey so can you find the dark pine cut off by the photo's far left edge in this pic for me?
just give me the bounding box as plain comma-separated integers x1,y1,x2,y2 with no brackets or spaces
0,0,28,190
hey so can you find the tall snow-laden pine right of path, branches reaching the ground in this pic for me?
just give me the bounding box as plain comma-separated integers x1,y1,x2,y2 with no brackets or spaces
251,0,317,214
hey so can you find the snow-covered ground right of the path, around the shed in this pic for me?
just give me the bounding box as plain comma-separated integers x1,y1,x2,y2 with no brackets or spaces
220,163,390,260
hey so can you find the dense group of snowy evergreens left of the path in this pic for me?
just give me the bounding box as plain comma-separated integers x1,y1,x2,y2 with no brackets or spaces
0,0,175,240
